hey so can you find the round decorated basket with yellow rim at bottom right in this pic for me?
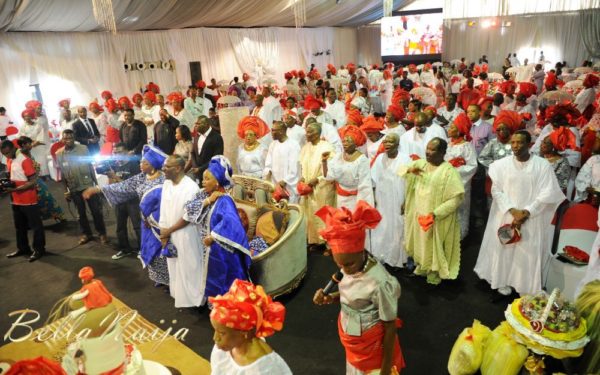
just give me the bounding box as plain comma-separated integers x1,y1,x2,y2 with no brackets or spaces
504,289,589,359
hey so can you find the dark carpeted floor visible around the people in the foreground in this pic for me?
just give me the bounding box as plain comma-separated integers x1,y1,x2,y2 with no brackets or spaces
0,182,508,375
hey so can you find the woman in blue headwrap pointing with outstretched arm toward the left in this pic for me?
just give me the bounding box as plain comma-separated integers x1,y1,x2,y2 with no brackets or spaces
83,145,169,286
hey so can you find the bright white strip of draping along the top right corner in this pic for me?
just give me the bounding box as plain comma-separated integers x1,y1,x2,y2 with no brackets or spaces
443,0,600,20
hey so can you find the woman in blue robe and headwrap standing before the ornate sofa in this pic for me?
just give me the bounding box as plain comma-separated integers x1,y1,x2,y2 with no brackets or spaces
184,155,251,297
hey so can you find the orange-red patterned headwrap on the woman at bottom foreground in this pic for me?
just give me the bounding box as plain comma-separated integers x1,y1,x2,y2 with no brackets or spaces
208,279,285,337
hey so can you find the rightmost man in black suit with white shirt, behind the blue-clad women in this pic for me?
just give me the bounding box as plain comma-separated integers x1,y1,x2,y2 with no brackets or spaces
185,116,223,180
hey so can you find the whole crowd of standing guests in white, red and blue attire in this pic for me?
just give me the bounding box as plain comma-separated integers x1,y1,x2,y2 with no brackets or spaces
0,56,600,374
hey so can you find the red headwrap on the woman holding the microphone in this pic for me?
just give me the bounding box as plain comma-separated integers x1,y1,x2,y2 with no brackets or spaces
315,200,381,254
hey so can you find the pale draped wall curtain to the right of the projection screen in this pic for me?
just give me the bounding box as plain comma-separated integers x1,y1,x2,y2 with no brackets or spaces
443,13,590,71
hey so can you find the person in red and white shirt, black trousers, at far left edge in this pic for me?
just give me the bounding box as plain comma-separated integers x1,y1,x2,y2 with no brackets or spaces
0,140,46,262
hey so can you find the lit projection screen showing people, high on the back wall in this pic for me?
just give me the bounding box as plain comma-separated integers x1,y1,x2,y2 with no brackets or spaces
381,13,443,56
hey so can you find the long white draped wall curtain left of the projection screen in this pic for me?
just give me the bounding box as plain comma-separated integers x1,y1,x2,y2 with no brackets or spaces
0,27,366,121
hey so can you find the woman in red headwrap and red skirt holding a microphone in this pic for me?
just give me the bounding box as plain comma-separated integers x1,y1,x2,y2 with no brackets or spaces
313,201,405,375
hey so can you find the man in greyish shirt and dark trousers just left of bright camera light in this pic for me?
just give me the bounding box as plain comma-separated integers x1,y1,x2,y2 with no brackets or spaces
56,129,108,245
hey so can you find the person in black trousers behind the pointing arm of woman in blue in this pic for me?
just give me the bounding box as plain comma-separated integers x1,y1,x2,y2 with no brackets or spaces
103,143,141,260
